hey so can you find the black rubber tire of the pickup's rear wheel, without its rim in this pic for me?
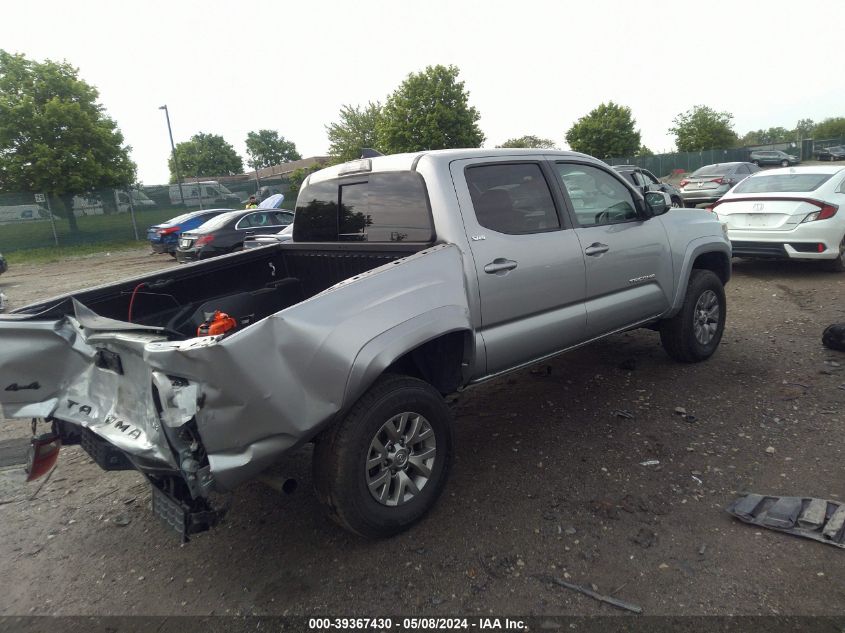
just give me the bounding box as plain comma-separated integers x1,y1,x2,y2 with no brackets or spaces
313,374,452,538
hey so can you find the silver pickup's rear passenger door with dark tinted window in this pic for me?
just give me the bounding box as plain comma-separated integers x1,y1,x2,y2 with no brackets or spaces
451,157,586,374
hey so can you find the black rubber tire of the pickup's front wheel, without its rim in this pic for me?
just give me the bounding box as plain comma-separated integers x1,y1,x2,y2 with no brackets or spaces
660,269,726,363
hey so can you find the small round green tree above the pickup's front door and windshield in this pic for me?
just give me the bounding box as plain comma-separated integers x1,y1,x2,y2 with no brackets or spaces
566,101,640,158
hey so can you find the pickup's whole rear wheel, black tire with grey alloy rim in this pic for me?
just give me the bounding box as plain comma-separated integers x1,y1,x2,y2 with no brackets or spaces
313,375,452,538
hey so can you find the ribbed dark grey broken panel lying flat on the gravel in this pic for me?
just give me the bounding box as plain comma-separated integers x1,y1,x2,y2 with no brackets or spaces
726,494,845,548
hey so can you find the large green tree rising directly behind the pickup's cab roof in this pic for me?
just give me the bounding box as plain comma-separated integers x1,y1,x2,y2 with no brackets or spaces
376,65,484,154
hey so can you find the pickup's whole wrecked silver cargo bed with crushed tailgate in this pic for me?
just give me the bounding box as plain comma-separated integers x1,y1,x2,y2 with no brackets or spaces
0,243,468,537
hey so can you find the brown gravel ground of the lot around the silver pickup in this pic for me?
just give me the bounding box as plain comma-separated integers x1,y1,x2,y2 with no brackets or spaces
0,250,845,616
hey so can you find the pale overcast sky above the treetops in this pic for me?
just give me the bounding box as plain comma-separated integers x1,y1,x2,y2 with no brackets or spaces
0,0,845,184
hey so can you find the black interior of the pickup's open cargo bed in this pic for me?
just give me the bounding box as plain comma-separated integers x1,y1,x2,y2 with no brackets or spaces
9,243,429,340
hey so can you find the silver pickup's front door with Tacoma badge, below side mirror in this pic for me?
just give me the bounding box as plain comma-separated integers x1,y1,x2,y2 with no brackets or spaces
554,161,674,338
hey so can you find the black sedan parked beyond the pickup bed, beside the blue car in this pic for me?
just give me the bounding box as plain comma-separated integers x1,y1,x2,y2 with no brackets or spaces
176,209,293,262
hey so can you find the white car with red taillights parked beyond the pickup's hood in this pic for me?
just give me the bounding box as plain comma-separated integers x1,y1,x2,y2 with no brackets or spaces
713,165,845,272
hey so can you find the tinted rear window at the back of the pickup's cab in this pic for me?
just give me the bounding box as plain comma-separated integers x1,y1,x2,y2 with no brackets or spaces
293,171,434,243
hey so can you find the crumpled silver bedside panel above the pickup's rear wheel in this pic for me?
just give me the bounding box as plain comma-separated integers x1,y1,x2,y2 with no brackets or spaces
144,246,470,488
